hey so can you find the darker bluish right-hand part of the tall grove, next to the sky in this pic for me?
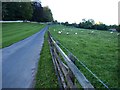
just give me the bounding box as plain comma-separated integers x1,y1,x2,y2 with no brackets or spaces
31,2,53,22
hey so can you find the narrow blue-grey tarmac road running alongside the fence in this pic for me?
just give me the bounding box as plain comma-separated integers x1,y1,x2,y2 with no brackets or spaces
2,26,48,88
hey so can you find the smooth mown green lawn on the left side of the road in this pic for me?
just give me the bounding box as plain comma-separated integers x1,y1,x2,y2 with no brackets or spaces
1,23,45,48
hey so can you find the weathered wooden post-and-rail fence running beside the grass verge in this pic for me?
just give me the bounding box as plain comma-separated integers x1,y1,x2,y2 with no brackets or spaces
48,31,94,89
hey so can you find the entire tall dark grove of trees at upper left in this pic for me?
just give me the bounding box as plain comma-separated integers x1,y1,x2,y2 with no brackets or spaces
2,2,53,22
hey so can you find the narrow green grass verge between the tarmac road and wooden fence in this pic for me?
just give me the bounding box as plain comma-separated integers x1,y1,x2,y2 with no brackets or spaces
35,33,58,88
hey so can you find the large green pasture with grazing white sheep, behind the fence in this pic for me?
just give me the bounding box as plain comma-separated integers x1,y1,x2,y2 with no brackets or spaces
49,25,120,88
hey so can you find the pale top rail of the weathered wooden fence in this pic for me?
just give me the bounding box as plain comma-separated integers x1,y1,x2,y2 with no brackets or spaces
49,33,94,89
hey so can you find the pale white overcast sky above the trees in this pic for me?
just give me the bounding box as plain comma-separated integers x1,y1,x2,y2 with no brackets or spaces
40,0,120,25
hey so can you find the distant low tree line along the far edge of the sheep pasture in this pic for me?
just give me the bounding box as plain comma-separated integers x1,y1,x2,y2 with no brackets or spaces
54,19,120,32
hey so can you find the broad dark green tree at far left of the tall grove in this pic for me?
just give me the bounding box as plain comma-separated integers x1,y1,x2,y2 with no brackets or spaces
2,2,33,20
